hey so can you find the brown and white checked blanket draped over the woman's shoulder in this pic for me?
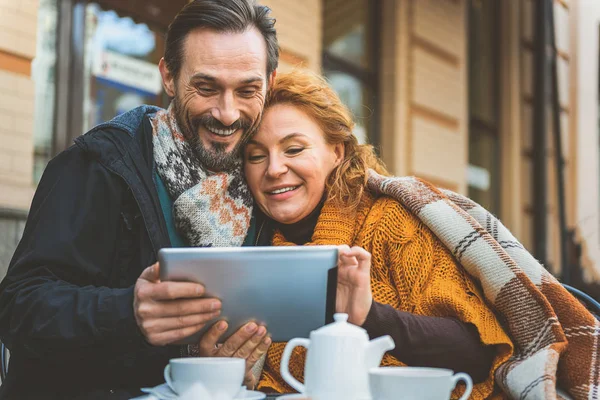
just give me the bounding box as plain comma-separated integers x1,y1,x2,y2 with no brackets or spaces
367,171,600,399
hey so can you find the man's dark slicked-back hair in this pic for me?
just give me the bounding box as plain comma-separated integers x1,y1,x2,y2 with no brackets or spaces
165,0,279,79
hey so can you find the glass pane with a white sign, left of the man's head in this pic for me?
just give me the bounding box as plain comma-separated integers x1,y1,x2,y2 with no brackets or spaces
83,3,164,132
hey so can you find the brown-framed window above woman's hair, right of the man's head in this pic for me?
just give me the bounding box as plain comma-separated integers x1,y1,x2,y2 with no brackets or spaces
323,0,380,145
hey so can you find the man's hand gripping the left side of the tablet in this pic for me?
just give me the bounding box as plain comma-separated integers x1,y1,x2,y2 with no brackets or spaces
133,263,221,346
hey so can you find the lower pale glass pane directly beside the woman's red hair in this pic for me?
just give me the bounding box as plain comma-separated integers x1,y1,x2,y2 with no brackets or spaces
323,70,373,143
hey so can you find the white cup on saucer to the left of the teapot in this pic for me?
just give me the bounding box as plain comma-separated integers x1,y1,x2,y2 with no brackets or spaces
164,357,246,400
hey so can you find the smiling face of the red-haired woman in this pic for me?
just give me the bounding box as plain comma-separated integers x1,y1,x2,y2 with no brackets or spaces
244,104,344,224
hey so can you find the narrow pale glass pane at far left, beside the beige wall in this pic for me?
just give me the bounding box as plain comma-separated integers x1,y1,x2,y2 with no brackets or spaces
31,0,58,184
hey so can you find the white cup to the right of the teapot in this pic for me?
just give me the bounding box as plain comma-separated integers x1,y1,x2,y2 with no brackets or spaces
369,367,473,400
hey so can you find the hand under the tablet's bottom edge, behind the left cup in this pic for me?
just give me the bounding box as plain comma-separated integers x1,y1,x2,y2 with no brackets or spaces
199,321,271,389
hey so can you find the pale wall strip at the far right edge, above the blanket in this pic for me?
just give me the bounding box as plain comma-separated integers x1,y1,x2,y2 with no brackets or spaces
572,0,600,281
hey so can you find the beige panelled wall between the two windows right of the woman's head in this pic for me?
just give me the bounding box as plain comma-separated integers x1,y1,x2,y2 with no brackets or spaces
381,0,468,193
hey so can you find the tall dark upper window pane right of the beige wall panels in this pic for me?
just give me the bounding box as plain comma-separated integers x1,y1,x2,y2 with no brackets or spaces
469,0,499,125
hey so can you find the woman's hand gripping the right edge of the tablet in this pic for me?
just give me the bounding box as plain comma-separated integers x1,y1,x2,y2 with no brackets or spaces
335,245,373,326
